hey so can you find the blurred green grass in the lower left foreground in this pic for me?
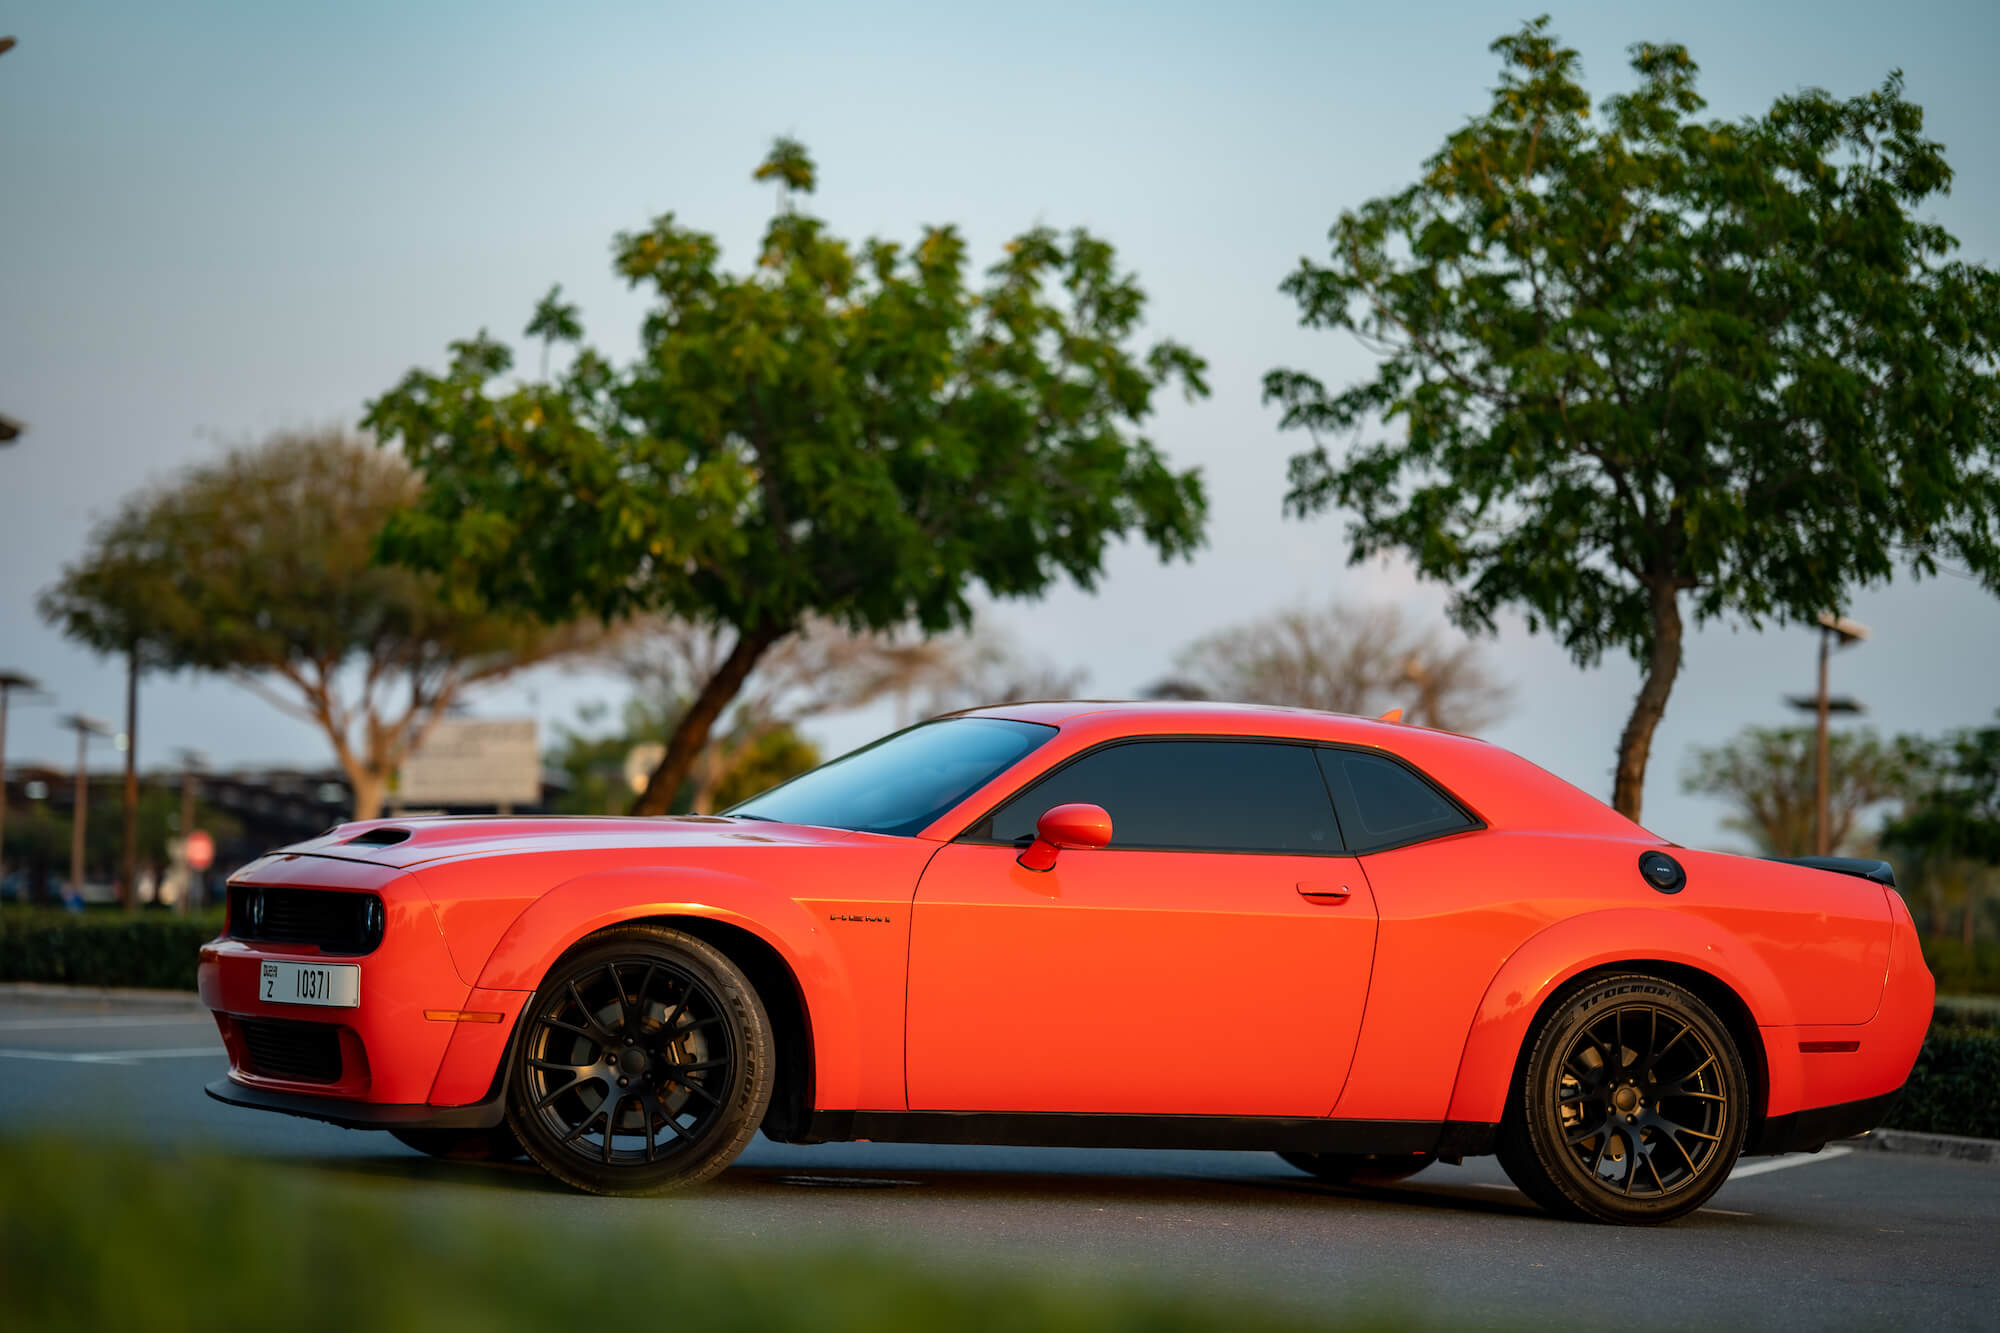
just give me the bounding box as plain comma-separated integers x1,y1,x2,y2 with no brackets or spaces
0,1141,1416,1333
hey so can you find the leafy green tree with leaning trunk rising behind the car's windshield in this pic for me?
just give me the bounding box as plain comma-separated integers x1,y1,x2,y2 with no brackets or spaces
368,140,1206,813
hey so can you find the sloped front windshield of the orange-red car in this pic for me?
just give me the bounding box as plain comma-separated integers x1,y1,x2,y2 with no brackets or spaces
726,717,1056,837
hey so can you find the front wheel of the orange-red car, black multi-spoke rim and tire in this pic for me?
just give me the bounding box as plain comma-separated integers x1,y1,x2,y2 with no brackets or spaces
506,927,776,1195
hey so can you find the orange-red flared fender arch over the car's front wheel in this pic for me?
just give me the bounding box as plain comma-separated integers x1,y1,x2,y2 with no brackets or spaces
478,867,860,1107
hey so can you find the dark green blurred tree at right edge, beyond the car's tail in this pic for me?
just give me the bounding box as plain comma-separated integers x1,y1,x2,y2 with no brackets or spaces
1882,725,2000,949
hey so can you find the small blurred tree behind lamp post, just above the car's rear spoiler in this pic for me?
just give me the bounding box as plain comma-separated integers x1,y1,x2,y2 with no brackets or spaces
1680,727,1910,857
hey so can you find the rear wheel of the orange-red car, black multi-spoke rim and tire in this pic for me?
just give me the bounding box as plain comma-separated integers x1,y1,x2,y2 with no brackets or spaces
1498,973,1750,1227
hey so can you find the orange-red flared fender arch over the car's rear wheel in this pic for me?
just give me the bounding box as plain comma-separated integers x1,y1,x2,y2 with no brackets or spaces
1450,907,1794,1125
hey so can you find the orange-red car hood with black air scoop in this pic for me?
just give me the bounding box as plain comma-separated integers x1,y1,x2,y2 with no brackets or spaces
238,815,856,875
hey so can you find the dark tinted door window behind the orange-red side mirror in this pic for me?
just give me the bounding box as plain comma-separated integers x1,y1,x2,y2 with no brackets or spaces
988,741,1340,853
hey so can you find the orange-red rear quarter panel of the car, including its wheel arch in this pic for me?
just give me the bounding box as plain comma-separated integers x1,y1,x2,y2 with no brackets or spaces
1336,827,1890,1123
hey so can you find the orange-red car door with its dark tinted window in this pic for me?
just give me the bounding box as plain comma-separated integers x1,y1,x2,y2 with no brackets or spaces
906,739,1376,1117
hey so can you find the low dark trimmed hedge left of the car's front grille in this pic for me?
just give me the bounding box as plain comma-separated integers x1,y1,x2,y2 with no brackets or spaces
0,909,222,991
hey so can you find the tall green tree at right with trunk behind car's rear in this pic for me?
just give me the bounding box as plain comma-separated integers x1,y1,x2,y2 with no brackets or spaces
1264,18,2000,819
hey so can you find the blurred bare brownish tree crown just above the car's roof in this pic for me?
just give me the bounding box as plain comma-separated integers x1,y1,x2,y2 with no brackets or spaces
1176,602,1508,733
